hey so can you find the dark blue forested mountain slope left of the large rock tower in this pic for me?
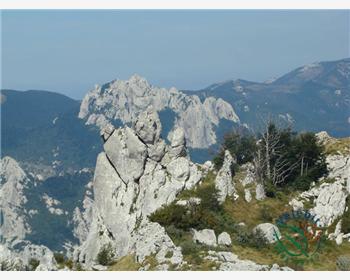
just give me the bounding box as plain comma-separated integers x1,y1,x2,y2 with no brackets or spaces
1,90,101,175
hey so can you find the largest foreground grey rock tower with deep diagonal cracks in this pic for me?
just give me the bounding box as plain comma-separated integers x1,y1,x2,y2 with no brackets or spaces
74,107,202,268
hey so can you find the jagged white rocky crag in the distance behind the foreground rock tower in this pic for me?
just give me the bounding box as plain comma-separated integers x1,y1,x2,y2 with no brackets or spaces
79,75,239,148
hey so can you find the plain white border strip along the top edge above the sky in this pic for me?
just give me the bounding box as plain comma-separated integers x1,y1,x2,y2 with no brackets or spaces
0,0,350,9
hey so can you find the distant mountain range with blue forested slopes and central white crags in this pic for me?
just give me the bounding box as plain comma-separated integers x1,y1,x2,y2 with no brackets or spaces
1,58,350,173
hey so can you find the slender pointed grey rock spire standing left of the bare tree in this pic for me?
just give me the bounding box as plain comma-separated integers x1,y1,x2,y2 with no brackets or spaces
215,150,238,203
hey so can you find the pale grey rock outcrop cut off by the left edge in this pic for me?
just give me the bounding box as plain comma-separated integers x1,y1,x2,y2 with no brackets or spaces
0,157,30,244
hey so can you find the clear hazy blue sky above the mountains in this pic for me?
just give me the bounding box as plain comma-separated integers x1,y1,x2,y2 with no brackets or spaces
0,10,350,99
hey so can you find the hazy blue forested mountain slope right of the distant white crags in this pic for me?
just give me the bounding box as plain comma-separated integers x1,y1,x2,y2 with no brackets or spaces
185,58,350,137
